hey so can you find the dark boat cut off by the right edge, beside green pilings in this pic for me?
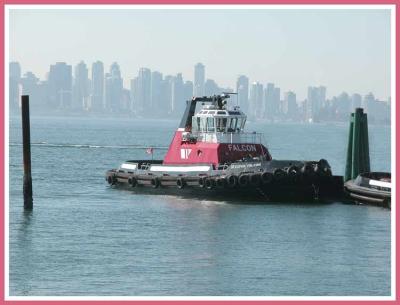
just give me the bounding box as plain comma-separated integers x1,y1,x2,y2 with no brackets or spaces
344,172,392,209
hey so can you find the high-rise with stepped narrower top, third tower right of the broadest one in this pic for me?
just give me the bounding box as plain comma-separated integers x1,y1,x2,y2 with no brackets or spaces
104,62,123,112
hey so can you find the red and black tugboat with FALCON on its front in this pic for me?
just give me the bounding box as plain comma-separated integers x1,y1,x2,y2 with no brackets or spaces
106,93,343,201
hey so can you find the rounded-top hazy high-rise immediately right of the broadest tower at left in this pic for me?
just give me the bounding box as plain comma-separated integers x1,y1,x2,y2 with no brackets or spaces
72,61,89,110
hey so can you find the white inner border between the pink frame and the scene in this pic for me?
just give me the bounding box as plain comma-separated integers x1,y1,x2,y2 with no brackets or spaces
4,4,396,301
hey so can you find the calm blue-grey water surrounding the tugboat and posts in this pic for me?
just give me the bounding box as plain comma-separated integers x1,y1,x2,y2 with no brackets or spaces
9,117,390,296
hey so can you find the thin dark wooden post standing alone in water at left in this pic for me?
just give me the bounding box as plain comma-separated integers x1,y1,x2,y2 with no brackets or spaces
21,95,33,210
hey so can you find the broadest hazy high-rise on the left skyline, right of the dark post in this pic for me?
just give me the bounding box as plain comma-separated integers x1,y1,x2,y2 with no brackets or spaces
48,62,72,109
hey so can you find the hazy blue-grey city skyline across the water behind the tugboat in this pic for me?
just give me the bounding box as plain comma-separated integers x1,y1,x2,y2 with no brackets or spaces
9,61,391,123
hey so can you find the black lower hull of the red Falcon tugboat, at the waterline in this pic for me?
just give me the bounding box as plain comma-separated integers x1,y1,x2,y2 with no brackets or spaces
106,170,343,202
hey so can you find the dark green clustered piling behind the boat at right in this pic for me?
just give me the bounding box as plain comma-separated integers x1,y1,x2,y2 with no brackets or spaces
344,108,371,181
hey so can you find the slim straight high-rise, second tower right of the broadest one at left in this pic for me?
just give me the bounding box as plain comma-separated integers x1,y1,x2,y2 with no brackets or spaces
89,61,104,112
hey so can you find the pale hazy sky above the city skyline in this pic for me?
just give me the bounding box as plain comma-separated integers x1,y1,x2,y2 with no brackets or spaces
9,7,390,99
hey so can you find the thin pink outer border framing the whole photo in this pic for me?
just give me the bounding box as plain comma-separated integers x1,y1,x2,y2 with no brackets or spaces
0,0,400,305
